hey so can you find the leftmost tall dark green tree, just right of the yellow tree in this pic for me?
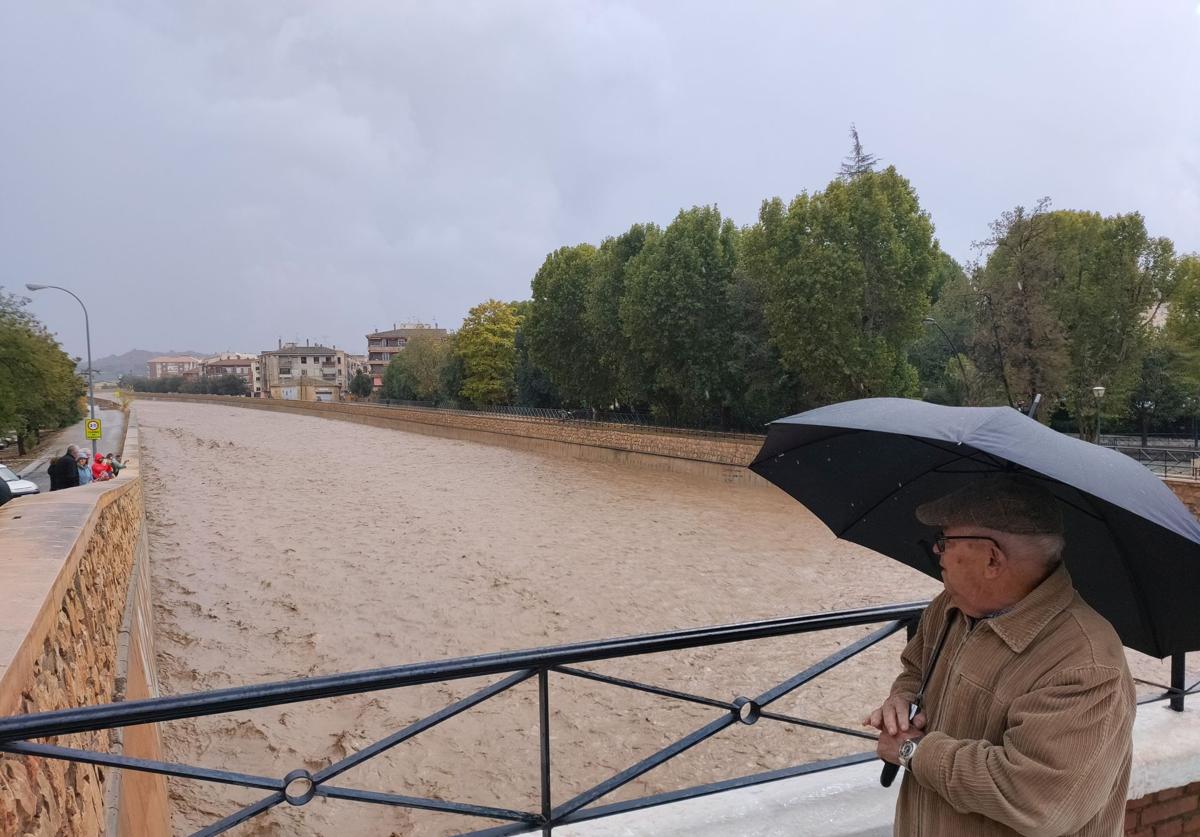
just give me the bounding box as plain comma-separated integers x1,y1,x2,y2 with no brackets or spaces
521,245,605,405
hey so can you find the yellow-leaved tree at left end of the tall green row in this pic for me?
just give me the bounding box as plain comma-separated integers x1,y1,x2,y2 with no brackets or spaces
453,300,521,404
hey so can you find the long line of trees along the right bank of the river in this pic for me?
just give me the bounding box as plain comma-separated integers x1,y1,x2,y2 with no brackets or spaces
442,126,1200,435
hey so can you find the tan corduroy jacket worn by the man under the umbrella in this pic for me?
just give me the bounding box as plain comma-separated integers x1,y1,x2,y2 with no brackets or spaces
892,566,1136,837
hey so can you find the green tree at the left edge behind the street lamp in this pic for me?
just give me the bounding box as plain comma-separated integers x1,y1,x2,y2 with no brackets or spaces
0,290,85,453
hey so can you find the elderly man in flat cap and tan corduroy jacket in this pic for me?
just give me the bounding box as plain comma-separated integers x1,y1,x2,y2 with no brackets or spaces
864,475,1135,837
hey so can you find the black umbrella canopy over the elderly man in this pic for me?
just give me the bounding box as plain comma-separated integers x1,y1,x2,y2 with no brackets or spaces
750,398,1200,657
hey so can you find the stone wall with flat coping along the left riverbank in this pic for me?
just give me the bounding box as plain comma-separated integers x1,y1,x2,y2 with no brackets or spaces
0,414,168,837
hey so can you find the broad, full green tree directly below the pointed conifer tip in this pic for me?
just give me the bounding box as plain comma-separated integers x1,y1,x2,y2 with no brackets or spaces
743,167,937,407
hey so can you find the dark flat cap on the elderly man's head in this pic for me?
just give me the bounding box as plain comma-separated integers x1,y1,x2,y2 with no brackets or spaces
917,474,1062,535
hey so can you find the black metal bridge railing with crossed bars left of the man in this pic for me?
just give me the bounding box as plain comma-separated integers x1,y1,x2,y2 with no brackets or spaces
0,603,924,837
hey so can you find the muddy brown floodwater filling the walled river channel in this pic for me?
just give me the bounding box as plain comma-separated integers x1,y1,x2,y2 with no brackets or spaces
136,402,1190,836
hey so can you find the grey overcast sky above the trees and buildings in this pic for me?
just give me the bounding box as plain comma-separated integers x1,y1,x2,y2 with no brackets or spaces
0,0,1200,357
